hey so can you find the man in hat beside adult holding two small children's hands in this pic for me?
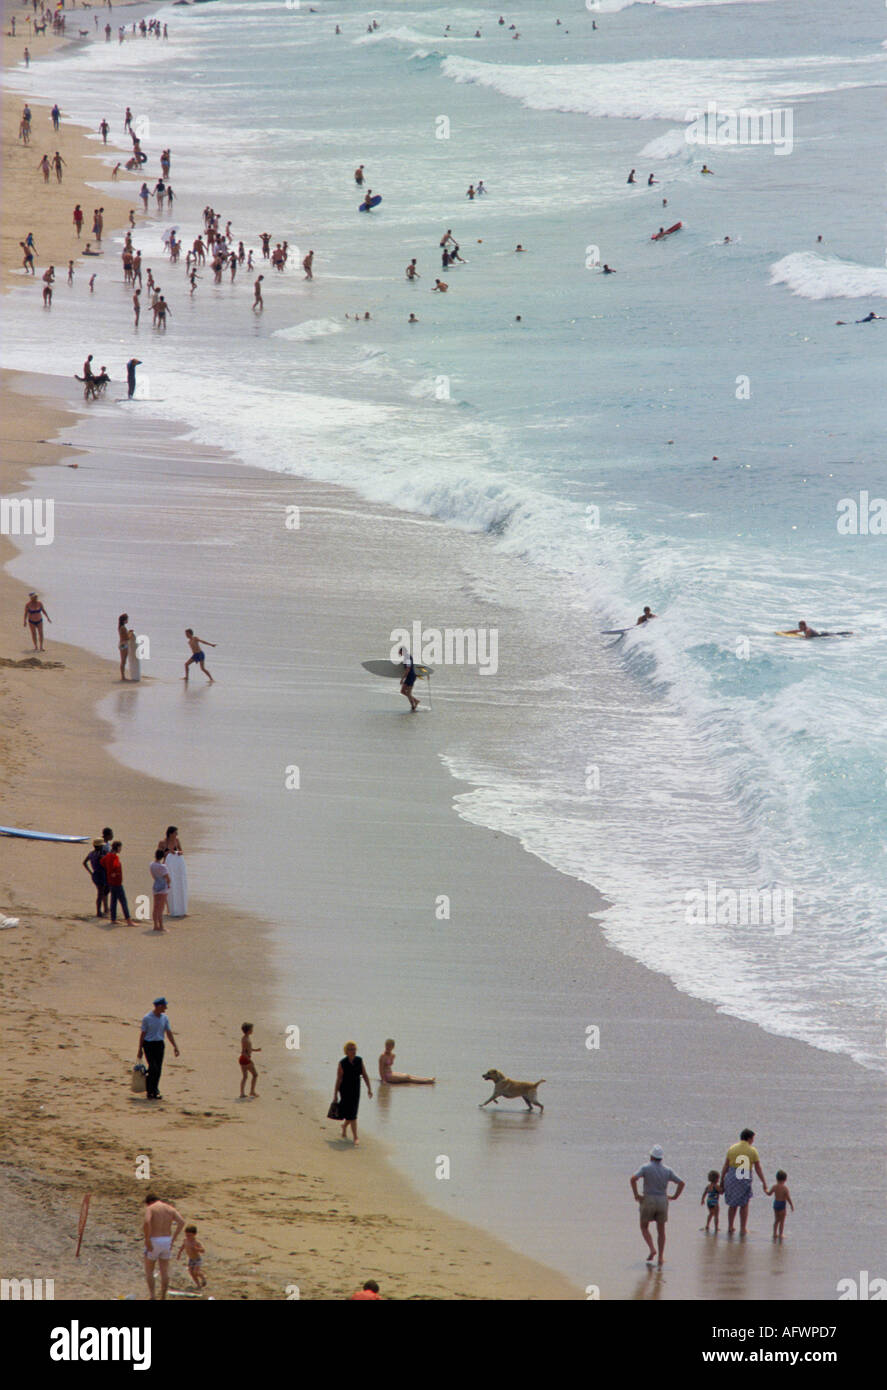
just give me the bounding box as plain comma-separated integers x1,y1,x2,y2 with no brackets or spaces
630,1129,795,1268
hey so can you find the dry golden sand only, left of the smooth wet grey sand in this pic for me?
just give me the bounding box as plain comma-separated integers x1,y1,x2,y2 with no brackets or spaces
0,2,580,1298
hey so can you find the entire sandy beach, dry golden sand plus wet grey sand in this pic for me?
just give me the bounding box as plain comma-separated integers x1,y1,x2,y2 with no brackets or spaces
0,0,884,1301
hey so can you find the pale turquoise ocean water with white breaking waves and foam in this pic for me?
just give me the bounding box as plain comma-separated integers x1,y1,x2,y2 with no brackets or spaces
3,0,887,1070
